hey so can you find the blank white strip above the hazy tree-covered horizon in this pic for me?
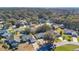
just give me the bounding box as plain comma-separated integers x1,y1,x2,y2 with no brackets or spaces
0,0,79,7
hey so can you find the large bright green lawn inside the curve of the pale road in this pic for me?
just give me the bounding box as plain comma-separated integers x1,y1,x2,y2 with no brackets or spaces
55,44,79,51
